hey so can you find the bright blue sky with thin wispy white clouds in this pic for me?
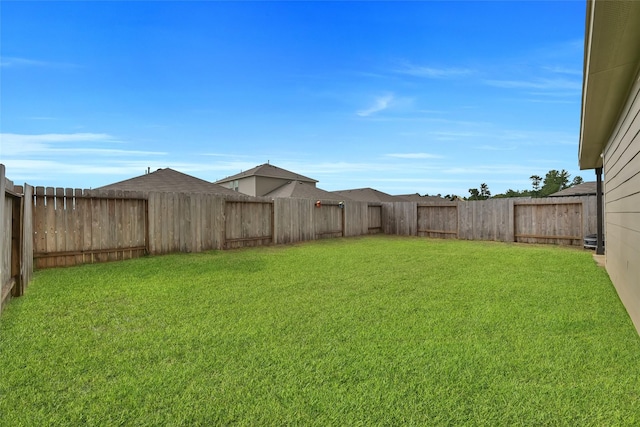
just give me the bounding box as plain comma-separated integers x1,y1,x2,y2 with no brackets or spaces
0,1,593,196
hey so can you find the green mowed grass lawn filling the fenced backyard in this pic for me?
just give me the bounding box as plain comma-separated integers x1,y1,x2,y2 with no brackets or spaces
0,236,640,426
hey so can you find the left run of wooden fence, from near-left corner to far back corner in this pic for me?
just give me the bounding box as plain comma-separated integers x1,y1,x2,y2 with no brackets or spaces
32,191,375,268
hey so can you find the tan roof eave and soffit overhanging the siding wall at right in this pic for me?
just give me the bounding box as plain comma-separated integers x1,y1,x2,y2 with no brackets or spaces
578,0,640,169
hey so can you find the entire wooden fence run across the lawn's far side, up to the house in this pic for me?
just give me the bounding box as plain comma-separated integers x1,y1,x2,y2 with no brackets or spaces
26,191,596,268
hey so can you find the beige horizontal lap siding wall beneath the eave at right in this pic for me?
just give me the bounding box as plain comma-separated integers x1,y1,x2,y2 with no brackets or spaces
604,69,640,331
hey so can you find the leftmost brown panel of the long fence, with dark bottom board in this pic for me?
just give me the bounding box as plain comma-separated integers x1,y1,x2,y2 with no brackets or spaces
33,187,147,268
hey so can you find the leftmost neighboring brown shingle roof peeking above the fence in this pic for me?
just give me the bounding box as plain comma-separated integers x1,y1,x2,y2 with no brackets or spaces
96,168,238,196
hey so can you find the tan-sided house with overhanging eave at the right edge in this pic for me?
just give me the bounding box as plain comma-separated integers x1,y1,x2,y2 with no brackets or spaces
578,0,640,331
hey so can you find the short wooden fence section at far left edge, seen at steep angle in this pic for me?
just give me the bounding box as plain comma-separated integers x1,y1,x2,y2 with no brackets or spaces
0,164,33,311
